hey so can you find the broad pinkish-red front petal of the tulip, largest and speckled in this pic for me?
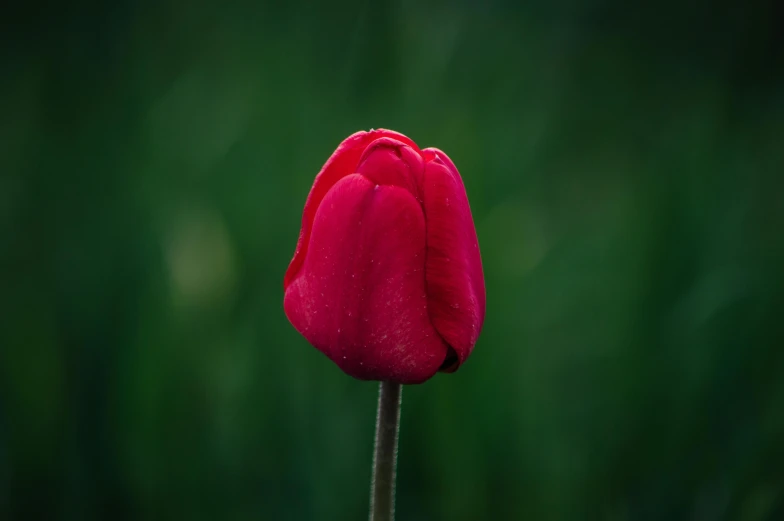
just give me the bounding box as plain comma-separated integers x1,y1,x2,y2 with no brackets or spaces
284,174,448,384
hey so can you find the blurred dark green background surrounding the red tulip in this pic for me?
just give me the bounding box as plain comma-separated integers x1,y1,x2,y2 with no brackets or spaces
0,0,784,521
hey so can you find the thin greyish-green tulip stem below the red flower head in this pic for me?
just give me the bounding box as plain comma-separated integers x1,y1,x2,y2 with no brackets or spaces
370,382,402,521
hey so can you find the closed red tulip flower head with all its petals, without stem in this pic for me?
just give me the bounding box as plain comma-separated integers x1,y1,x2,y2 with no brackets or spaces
284,130,485,384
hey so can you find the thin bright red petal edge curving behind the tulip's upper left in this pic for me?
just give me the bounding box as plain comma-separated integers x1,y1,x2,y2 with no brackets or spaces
283,129,419,288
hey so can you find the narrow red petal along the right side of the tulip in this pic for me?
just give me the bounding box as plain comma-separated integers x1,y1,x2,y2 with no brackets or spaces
422,148,485,370
